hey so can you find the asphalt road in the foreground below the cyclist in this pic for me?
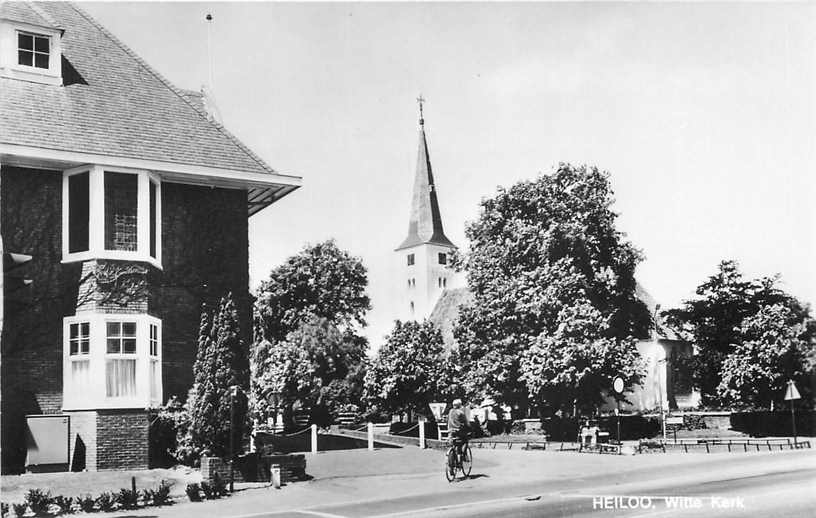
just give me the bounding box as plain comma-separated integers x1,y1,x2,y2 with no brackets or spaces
250,451,816,518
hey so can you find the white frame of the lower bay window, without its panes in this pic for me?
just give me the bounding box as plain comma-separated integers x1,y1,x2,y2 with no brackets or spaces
62,312,163,410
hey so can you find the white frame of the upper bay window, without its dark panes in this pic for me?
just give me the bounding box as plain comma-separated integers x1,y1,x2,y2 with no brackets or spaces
62,165,162,269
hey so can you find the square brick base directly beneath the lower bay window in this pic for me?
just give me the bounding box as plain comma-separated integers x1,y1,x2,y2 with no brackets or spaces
96,410,150,471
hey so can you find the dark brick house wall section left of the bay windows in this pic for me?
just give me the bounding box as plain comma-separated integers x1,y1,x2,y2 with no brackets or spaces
0,166,64,472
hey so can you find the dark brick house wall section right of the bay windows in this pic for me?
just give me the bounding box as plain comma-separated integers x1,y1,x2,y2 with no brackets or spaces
149,183,251,401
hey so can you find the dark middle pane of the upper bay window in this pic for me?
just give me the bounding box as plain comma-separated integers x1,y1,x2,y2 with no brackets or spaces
105,172,139,251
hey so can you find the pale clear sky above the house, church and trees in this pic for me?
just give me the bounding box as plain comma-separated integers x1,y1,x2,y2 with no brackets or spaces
82,2,816,349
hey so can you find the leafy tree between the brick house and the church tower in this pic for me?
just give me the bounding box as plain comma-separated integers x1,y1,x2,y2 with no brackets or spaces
252,240,371,428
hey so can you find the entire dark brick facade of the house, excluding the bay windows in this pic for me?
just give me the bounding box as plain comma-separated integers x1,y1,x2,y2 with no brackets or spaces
0,166,251,472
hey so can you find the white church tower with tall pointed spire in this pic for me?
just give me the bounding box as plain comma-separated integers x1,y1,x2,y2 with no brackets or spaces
395,96,456,321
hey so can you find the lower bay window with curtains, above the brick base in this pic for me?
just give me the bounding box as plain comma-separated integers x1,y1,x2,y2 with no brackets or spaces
63,313,162,410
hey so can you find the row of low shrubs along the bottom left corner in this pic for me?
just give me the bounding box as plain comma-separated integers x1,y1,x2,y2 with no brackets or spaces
0,480,172,518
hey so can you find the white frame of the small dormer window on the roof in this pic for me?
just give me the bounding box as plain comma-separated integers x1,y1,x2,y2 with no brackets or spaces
0,20,62,85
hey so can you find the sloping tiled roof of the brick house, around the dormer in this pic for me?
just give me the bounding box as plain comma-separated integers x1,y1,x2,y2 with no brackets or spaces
0,2,274,178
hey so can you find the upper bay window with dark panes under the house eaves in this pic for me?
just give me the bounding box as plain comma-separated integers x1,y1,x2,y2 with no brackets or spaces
62,165,161,268
